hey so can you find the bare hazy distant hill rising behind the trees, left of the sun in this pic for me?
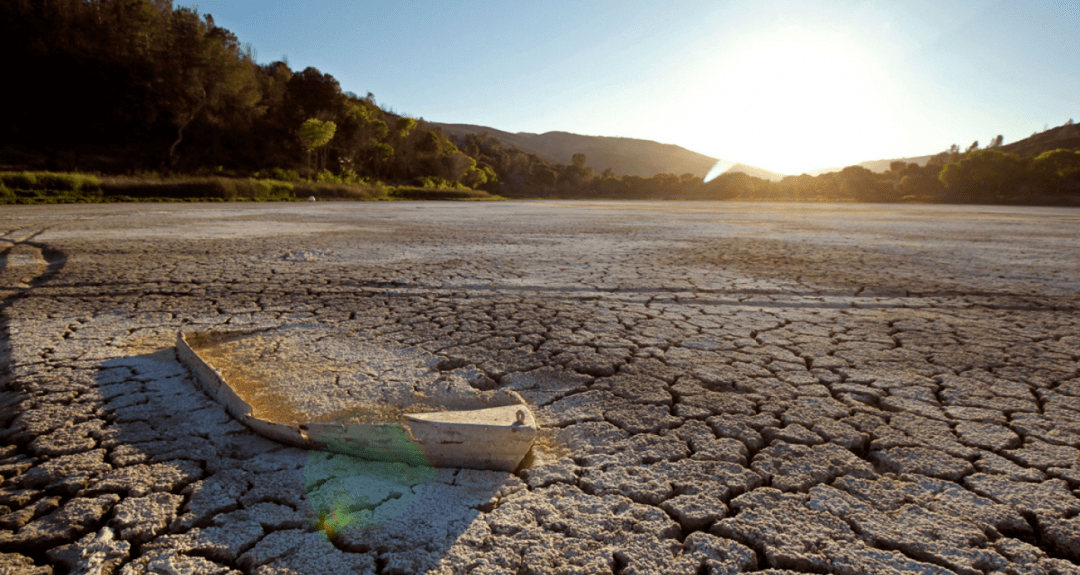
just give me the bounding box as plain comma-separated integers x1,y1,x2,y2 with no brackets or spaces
429,122,783,179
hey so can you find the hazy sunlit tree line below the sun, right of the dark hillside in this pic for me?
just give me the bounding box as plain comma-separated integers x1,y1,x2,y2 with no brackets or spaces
481,132,1080,204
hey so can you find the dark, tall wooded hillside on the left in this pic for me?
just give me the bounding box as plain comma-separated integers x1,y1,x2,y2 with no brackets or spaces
0,0,496,187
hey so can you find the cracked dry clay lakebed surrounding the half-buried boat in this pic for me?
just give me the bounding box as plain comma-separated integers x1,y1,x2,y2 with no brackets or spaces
0,202,1080,575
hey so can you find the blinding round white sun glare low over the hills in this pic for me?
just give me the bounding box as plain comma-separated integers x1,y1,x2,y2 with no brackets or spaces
688,31,895,174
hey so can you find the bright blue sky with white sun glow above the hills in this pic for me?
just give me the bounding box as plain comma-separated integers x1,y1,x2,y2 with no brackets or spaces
185,0,1080,174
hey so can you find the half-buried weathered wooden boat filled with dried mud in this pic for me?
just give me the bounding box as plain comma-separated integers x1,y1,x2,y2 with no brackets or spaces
176,325,538,471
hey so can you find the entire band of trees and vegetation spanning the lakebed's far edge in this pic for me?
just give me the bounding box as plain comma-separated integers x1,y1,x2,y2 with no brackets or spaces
0,0,1080,204
